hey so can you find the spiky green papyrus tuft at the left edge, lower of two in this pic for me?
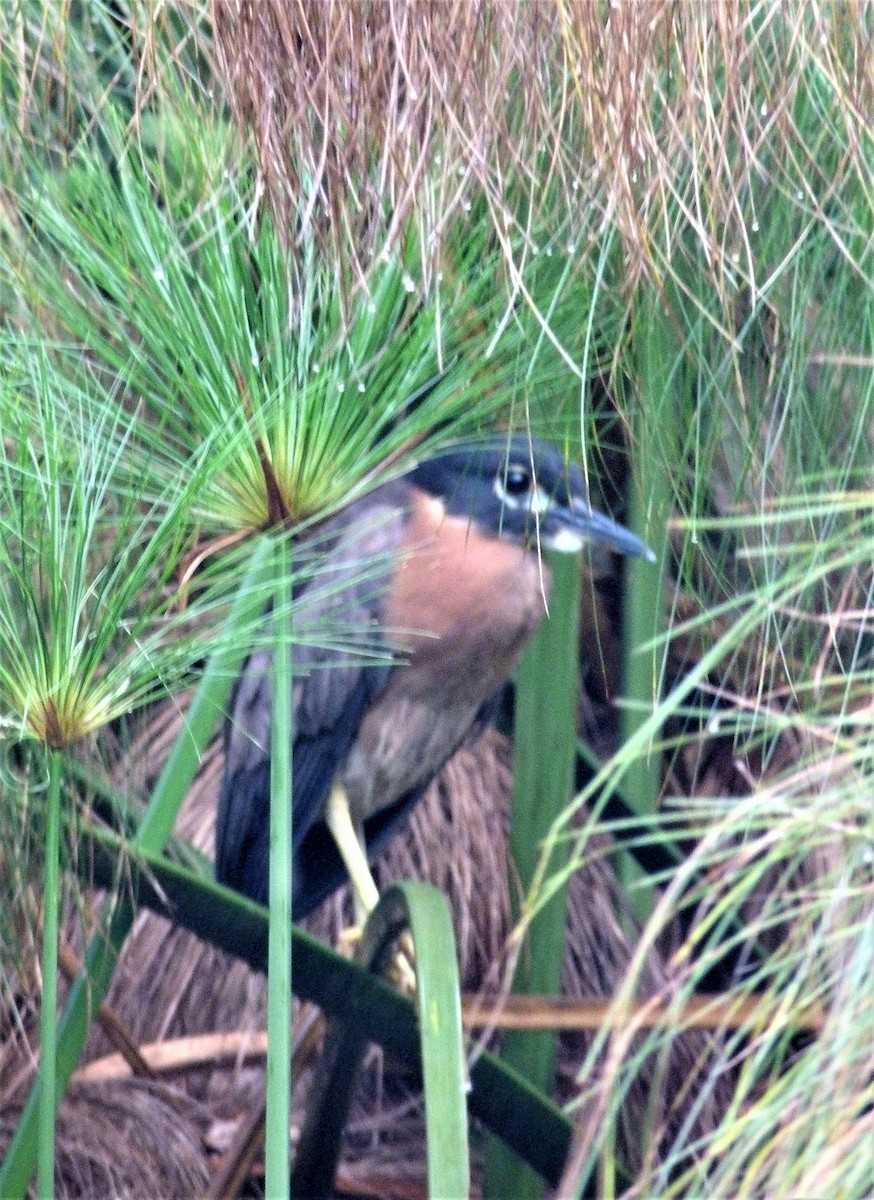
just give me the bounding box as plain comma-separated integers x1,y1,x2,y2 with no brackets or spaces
0,338,217,749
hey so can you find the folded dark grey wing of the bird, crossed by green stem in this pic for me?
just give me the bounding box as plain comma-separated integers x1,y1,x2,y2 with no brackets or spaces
216,484,408,917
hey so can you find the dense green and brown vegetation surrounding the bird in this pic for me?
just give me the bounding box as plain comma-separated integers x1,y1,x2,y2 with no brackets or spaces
0,0,874,1200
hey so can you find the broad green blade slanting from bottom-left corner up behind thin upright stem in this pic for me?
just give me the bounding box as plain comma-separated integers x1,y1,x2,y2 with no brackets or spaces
0,540,273,1200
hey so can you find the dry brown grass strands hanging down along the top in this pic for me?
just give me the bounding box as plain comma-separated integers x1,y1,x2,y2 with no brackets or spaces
212,0,874,287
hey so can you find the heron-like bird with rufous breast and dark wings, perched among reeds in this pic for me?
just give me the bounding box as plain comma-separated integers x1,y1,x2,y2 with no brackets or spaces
215,434,654,922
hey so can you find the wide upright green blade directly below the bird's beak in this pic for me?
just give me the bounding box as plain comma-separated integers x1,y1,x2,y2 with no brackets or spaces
485,554,580,1200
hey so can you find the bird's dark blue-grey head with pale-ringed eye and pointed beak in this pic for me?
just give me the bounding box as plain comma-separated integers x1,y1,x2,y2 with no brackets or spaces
408,436,656,562
